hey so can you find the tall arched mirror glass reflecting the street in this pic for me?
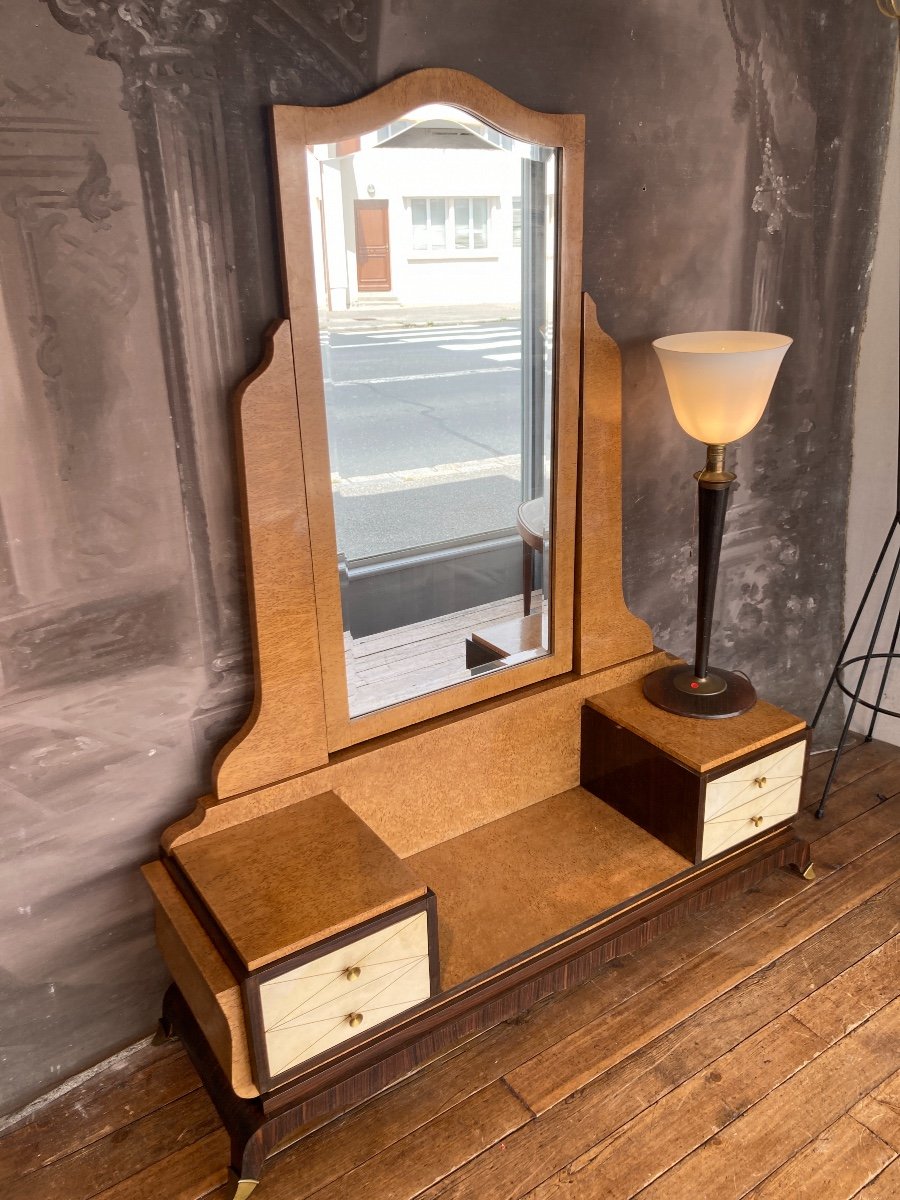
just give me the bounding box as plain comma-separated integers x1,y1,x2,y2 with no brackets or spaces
306,104,559,716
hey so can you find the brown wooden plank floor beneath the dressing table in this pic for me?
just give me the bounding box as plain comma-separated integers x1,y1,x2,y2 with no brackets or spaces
0,742,900,1200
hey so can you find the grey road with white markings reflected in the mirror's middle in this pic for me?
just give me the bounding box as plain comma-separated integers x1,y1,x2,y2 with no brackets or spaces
324,322,521,559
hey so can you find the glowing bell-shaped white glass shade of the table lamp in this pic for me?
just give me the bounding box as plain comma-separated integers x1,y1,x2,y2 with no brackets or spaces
653,329,792,445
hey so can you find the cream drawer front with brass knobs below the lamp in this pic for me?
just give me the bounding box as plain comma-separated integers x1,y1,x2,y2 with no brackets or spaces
700,738,806,859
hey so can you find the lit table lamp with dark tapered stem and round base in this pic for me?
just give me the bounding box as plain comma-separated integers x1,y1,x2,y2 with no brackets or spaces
643,330,792,718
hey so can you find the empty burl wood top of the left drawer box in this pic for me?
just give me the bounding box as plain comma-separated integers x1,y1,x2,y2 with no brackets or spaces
173,792,426,971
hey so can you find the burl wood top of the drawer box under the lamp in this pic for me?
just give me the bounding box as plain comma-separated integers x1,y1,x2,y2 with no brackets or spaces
586,679,806,775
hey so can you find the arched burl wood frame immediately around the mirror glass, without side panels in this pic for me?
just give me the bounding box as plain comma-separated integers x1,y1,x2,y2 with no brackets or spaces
275,70,584,750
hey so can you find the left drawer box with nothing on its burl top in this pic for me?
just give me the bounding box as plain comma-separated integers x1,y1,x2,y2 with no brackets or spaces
150,792,439,1093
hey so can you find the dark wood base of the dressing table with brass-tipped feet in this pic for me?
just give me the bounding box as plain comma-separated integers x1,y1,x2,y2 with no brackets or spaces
160,828,812,1200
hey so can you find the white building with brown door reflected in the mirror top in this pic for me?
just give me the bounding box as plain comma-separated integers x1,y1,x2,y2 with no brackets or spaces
308,104,553,311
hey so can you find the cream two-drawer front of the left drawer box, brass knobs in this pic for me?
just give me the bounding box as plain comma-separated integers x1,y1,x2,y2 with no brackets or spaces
259,912,431,1078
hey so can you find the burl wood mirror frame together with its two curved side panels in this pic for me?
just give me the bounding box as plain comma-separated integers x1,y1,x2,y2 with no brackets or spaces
208,68,652,799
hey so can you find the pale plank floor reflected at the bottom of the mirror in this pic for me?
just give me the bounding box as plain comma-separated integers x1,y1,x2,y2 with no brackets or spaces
344,592,546,716
